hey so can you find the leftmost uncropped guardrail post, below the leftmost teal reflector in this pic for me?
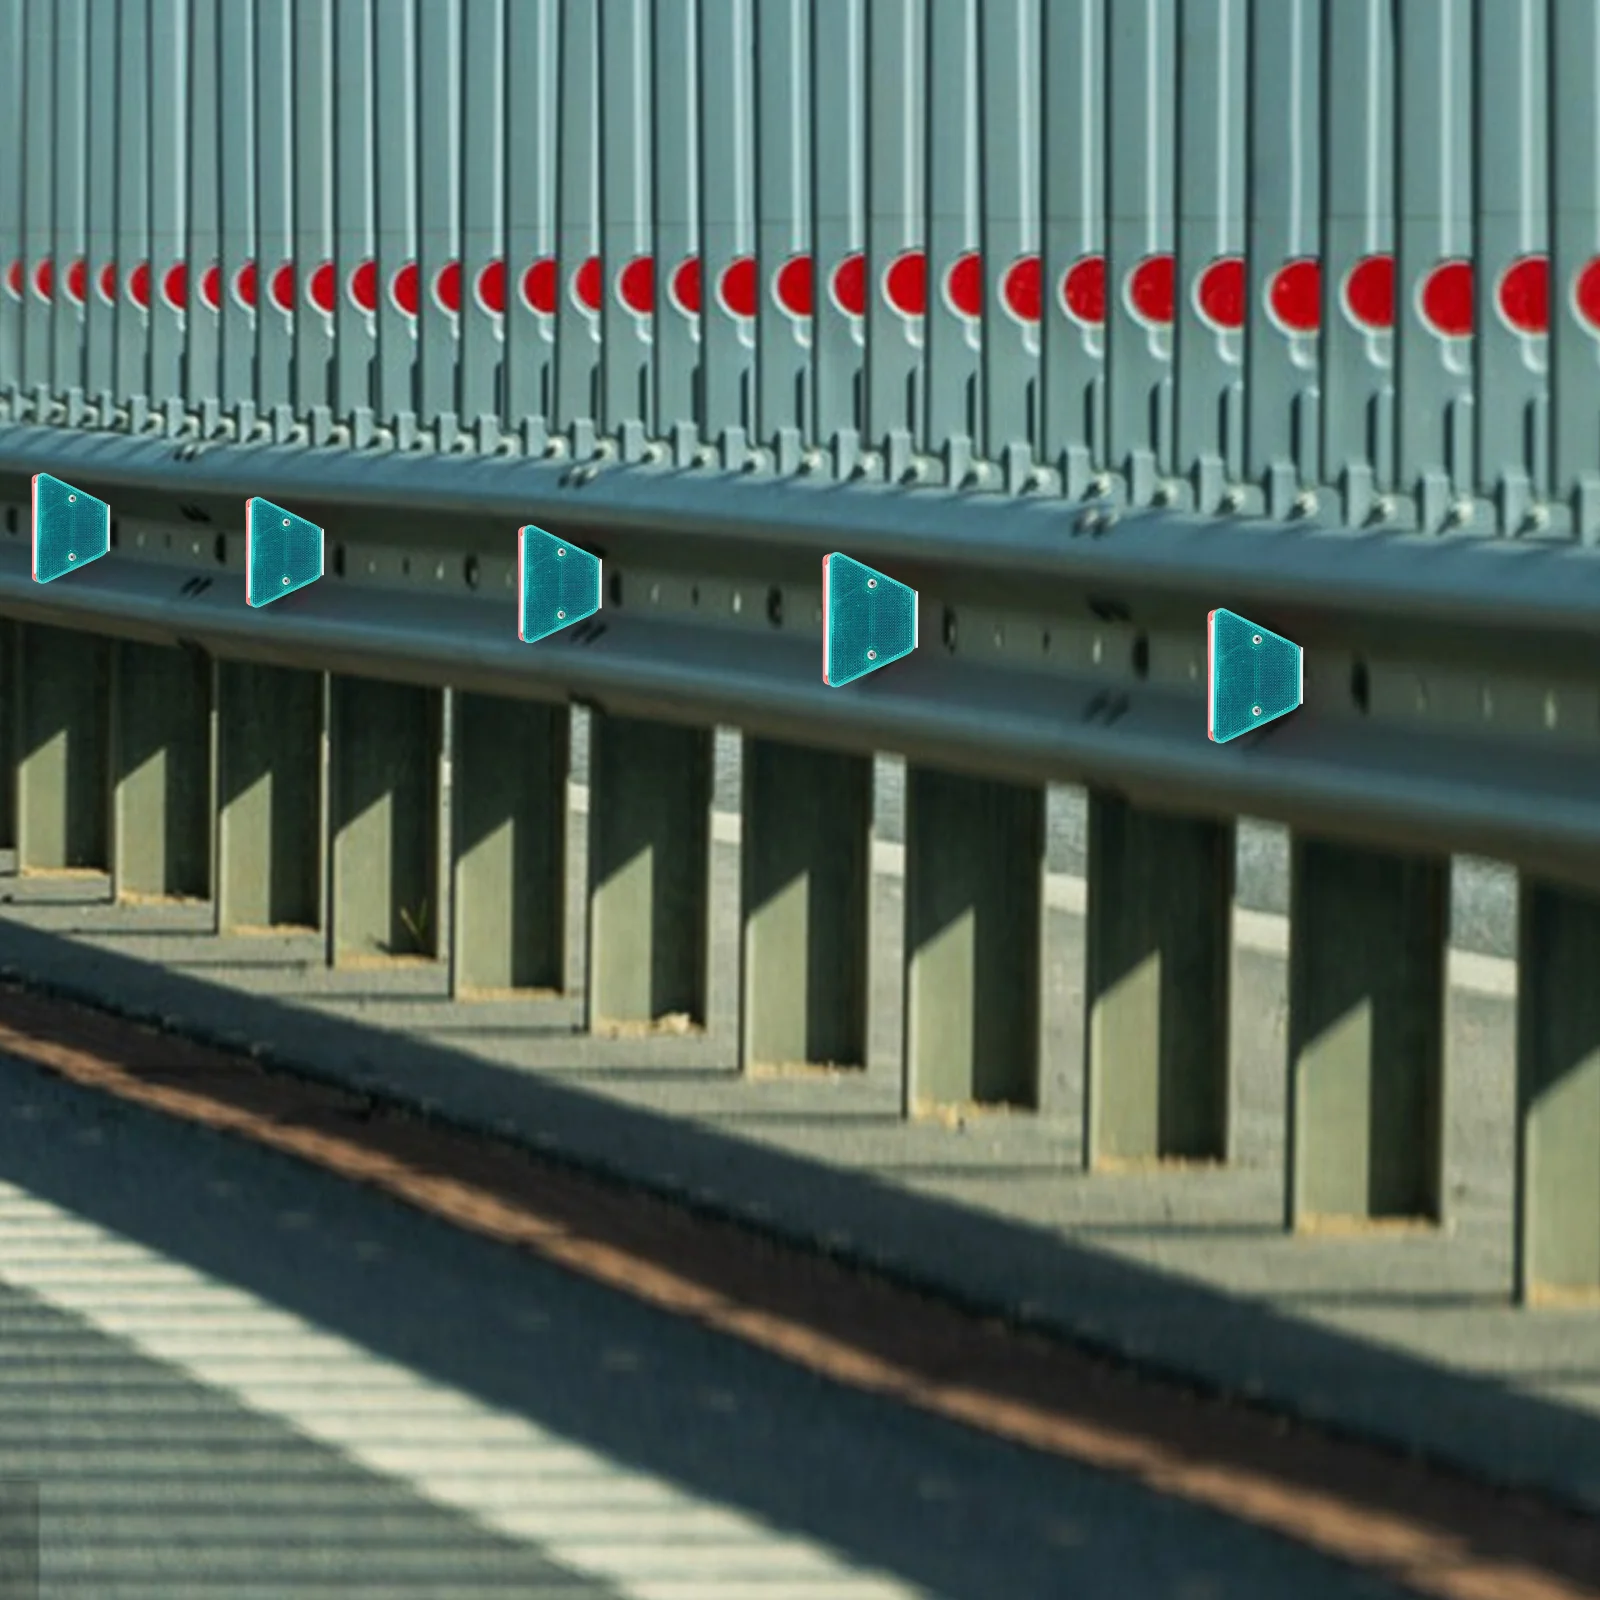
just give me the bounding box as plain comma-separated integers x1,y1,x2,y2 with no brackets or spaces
16,624,110,872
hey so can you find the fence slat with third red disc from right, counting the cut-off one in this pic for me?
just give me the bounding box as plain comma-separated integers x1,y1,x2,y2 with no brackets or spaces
1395,0,1477,533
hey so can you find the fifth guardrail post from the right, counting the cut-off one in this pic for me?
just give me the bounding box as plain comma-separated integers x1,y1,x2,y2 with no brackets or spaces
739,738,872,1069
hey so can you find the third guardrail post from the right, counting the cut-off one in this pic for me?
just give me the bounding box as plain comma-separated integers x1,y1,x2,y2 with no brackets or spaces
1083,790,1234,1168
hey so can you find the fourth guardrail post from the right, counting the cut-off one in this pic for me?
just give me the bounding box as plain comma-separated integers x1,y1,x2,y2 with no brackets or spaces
906,765,1045,1114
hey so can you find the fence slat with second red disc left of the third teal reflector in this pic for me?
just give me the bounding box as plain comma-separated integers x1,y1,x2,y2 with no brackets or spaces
416,0,464,450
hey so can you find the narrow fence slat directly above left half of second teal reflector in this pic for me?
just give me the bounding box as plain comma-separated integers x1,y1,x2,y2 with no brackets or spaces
256,0,298,443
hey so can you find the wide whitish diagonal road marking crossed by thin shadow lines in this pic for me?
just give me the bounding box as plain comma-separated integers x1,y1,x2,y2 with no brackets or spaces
0,1184,926,1600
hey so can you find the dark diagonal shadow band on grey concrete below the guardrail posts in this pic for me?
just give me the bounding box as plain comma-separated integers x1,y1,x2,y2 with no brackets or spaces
0,922,1600,1536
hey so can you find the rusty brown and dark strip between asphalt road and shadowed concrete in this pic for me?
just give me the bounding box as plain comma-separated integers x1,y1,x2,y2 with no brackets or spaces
0,987,1600,1600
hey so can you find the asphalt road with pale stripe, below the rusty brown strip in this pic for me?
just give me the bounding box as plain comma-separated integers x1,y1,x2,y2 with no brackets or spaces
0,1058,1427,1600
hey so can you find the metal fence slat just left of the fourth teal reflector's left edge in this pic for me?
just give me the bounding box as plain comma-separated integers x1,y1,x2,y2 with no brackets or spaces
755,0,812,474
